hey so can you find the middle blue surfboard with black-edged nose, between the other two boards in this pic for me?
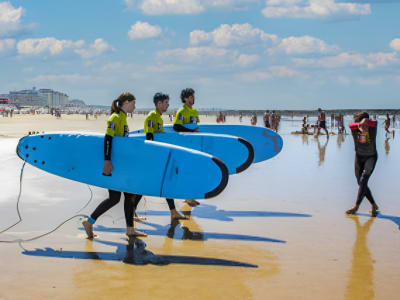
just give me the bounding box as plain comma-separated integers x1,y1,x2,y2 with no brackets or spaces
129,132,254,174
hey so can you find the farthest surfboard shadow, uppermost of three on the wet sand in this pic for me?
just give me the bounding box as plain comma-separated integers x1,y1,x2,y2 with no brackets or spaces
138,203,312,222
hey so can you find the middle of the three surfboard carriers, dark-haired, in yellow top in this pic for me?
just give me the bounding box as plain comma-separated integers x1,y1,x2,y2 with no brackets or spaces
134,93,185,221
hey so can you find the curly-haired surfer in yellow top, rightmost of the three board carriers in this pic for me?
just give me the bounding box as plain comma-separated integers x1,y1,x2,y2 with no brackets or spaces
174,88,200,206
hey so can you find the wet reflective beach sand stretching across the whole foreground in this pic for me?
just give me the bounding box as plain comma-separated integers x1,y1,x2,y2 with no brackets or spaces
0,115,400,299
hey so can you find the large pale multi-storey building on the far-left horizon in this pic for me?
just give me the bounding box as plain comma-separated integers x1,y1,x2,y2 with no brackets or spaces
8,87,68,107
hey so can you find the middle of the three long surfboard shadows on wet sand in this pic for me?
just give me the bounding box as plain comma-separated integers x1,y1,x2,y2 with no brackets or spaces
79,221,286,243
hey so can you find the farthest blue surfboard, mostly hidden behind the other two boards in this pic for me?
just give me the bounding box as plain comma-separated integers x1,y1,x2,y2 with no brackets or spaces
131,124,283,163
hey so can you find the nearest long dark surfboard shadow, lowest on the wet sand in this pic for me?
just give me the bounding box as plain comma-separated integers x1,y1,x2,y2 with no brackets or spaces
22,237,258,268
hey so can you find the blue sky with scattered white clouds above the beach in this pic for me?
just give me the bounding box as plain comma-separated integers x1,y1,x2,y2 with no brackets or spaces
0,0,400,109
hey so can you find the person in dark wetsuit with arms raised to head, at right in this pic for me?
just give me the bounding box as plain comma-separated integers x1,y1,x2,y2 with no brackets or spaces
346,112,379,216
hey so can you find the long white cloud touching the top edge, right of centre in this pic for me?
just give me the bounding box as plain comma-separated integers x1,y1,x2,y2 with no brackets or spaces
262,0,371,19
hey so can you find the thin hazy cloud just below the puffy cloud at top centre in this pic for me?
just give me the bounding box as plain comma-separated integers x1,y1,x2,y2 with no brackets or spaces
157,47,230,63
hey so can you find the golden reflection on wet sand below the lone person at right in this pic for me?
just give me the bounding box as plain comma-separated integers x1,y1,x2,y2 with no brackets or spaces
345,215,375,300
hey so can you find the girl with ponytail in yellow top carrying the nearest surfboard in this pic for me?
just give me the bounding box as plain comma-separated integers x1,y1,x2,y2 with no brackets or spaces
82,92,146,239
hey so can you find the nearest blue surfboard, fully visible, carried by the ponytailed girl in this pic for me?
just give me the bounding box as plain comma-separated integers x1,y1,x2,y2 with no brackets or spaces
17,133,229,199
